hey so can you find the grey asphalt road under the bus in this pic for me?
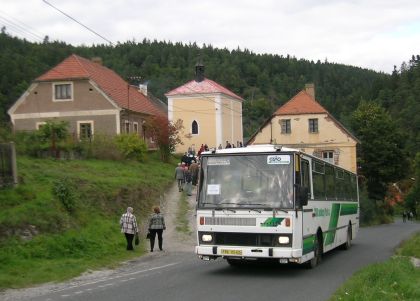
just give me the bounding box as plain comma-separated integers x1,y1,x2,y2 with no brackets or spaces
3,217,420,301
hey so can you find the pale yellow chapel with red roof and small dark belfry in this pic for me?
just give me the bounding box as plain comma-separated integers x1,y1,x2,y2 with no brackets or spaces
165,63,244,153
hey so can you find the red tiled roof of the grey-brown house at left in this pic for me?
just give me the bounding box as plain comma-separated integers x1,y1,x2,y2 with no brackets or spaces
36,54,166,115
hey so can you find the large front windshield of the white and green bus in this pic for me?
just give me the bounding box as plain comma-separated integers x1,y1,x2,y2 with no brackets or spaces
198,154,293,209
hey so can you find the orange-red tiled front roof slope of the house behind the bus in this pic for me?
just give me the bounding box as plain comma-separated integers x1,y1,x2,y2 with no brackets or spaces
274,91,328,115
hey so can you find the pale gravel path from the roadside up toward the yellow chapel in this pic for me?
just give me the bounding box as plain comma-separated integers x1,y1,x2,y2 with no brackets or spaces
0,182,196,301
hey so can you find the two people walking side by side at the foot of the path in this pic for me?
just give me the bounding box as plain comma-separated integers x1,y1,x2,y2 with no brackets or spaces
120,206,166,252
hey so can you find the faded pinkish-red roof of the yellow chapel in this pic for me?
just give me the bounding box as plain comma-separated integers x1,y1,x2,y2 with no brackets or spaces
165,78,243,101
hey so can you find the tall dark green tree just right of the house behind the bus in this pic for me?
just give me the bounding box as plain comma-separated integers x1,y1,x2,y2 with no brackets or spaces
351,101,407,200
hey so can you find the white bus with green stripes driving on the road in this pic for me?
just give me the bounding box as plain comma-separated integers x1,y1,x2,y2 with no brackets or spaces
195,145,359,267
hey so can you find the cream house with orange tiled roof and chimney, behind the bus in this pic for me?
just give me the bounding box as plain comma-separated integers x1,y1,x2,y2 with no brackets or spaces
247,84,359,172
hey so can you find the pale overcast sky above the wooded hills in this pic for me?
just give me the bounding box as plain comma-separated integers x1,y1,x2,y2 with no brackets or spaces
0,0,420,73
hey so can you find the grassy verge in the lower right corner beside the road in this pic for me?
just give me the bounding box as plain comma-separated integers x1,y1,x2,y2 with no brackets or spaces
330,233,420,301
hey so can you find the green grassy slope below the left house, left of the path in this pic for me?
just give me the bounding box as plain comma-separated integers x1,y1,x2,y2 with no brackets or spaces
0,155,174,289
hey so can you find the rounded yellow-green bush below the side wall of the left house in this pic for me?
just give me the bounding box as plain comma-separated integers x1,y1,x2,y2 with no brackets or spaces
115,134,147,161
